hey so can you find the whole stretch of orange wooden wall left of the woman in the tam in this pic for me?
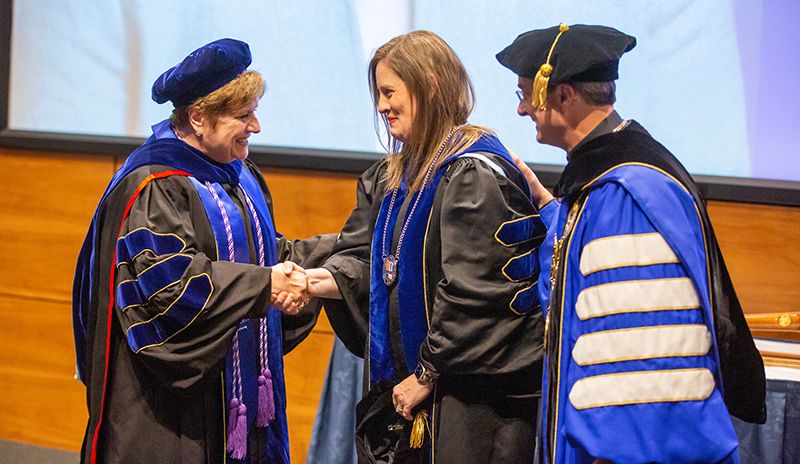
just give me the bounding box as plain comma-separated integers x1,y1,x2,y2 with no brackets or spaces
0,150,114,451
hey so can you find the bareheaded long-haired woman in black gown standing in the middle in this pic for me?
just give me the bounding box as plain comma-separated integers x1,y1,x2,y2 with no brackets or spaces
308,31,545,464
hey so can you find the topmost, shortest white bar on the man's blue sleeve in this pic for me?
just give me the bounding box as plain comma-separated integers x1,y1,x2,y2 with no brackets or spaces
580,233,678,275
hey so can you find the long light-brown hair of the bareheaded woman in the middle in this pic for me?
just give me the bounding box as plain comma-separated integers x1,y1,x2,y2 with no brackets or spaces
368,31,492,192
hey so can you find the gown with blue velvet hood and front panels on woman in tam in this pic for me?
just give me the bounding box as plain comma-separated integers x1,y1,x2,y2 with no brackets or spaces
74,138,332,462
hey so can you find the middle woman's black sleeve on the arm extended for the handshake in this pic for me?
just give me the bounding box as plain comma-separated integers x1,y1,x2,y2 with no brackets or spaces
322,160,386,358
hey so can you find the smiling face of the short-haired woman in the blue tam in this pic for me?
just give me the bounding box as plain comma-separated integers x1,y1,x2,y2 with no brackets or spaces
198,100,261,164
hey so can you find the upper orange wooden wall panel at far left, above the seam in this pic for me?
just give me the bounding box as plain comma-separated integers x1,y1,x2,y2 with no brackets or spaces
0,150,114,301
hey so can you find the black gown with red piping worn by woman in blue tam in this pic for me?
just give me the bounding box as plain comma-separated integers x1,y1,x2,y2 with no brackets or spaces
75,140,336,464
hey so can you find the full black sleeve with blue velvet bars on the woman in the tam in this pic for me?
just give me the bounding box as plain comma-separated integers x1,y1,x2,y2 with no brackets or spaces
115,176,271,389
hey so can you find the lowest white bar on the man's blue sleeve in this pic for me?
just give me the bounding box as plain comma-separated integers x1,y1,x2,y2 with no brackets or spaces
569,368,714,410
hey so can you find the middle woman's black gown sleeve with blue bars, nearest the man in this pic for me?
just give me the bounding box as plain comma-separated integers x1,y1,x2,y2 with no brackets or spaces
418,157,543,375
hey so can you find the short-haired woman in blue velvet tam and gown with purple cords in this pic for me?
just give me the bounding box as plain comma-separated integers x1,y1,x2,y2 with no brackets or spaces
73,39,335,464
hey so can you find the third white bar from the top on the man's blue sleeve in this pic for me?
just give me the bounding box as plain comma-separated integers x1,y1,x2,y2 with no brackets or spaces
572,325,711,366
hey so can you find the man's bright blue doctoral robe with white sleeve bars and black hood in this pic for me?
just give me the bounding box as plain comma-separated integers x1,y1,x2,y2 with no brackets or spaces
543,123,763,463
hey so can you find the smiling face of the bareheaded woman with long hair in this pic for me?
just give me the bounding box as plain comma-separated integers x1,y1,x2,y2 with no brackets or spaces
375,61,417,143
